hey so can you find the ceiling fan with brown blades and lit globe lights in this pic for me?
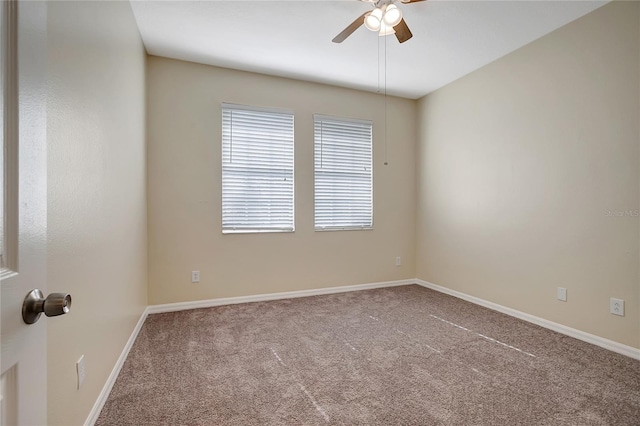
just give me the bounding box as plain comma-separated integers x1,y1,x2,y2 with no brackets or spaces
332,0,426,43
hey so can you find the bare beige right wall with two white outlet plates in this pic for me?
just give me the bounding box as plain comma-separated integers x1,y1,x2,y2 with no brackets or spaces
416,2,640,347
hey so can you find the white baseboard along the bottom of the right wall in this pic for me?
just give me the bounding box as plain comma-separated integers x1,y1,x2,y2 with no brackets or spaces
414,279,640,360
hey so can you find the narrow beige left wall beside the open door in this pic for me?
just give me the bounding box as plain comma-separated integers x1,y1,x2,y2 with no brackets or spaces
46,1,147,425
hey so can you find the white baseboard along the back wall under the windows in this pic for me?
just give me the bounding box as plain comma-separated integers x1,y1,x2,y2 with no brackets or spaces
147,279,416,314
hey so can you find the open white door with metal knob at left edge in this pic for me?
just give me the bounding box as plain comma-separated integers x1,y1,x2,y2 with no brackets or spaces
0,0,47,426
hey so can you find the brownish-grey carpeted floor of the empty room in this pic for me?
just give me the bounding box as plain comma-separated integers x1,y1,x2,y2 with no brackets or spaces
96,285,640,426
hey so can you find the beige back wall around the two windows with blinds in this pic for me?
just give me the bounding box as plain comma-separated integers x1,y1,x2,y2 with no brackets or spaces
147,57,416,304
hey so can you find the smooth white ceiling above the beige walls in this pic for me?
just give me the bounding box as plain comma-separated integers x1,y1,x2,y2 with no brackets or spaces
131,0,607,99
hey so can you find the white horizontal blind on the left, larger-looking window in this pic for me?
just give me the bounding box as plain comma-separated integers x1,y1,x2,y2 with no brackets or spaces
222,104,294,233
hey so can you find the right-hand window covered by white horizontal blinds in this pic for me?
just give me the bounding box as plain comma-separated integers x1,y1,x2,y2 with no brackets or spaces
314,114,373,231
